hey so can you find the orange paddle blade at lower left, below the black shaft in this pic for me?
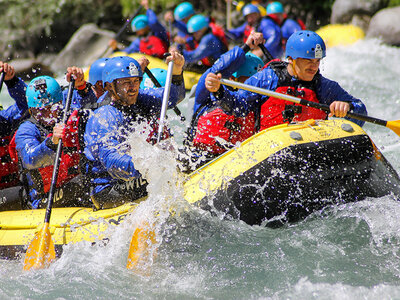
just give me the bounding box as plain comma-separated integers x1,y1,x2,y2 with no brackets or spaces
24,223,56,271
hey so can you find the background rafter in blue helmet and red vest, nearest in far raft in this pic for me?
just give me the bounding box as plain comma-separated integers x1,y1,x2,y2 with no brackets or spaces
171,15,228,72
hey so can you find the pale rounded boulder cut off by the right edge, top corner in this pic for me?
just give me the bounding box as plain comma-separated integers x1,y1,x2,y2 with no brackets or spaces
367,6,400,46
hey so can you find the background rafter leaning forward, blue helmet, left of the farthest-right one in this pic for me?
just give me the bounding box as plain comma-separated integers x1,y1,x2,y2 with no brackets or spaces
229,4,282,58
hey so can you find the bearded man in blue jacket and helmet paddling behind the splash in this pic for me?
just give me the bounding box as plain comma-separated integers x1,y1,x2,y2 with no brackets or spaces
84,51,185,209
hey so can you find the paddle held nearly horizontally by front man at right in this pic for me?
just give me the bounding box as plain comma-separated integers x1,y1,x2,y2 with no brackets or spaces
220,79,400,136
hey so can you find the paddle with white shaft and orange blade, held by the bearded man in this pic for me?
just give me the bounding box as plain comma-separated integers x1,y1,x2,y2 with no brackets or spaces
126,57,174,272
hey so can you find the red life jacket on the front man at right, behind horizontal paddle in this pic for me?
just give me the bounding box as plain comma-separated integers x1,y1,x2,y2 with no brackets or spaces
260,62,327,130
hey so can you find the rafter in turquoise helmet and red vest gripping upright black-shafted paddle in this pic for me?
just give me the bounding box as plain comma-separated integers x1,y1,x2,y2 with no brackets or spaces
15,71,90,208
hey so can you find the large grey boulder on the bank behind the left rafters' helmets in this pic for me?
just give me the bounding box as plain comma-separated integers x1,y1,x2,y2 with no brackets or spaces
50,23,115,73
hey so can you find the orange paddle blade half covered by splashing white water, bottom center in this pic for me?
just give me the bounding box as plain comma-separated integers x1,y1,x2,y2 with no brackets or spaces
126,223,156,275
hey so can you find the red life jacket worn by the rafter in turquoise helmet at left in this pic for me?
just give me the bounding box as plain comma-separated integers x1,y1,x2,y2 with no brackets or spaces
10,111,80,193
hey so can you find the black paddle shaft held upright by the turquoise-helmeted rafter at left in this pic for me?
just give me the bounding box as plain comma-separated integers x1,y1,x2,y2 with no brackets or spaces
44,77,75,223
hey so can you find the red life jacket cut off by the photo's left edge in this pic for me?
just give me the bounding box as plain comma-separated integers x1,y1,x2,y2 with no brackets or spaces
0,136,19,189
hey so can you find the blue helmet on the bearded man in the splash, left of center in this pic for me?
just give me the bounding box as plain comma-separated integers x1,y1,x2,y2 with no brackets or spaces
102,56,143,86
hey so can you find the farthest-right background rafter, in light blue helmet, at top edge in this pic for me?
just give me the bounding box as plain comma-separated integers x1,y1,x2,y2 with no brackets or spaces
267,1,305,48
